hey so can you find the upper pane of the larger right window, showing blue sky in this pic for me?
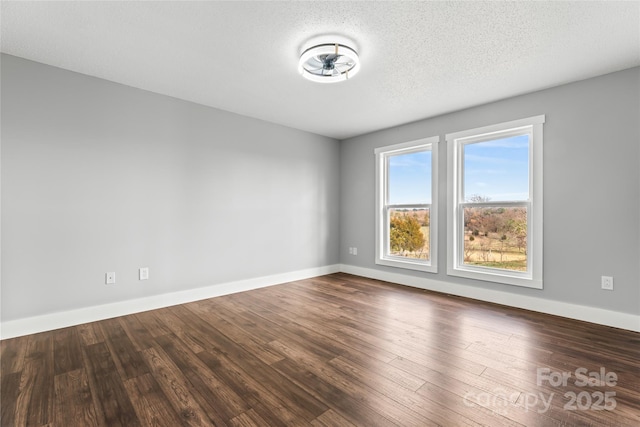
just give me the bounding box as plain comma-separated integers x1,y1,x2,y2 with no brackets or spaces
463,134,529,202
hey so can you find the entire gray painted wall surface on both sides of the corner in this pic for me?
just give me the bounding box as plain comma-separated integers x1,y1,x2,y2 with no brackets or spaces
0,55,640,321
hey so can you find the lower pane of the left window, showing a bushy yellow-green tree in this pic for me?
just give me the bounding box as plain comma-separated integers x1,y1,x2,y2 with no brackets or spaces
387,208,430,260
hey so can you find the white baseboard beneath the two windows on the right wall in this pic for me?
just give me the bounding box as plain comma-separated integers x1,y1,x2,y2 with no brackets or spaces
340,264,640,332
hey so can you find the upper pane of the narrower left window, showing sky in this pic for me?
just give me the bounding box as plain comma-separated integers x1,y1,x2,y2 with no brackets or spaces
387,151,431,205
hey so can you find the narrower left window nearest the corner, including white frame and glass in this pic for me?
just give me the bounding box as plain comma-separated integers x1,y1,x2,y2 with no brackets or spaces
375,137,438,273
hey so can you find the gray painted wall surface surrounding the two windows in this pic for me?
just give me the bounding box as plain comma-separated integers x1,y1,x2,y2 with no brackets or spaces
340,68,640,314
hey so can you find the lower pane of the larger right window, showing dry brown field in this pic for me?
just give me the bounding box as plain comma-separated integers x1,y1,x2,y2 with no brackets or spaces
463,207,527,271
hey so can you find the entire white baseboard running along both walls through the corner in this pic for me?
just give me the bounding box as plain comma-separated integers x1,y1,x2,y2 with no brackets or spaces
0,264,640,339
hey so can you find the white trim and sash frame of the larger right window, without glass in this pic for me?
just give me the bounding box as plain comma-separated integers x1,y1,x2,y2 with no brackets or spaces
445,115,545,289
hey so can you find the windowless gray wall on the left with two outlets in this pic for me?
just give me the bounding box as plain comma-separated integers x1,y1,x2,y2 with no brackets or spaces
1,55,340,321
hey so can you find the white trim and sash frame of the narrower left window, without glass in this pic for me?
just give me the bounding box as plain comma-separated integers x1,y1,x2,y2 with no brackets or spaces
375,136,440,273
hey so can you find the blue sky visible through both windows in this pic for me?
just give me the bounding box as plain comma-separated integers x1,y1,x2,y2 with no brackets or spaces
388,135,529,204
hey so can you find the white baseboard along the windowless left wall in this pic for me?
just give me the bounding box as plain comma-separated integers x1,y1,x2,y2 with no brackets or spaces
0,264,340,339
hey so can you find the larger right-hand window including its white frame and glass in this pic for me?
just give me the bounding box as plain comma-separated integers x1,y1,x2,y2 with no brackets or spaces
446,116,545,289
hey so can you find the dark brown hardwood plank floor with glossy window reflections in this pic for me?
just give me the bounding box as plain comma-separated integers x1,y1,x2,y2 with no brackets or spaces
1,273,640,427
